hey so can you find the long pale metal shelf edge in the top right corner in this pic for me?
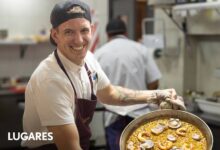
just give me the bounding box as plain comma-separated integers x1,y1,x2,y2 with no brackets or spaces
172,2,220,11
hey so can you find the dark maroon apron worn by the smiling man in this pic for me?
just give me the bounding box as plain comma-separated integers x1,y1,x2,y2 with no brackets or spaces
27,50,97,150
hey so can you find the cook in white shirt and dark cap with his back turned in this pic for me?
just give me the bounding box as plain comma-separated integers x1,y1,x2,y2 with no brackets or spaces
95,17,161,150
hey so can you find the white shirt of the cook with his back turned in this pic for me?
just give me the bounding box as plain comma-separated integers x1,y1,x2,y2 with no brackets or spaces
95,35,161,125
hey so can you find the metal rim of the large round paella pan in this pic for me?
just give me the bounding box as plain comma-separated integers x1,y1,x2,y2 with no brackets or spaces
120,109,213,150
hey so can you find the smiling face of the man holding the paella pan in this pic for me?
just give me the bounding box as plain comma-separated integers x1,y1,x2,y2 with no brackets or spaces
51,18,92,65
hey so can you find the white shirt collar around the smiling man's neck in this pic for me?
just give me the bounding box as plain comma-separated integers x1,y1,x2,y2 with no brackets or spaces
57,49,85,72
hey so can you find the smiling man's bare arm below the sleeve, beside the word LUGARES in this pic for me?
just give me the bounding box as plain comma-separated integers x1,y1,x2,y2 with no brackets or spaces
47,124,82,150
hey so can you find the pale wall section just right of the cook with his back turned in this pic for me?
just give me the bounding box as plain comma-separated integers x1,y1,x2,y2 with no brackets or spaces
155,9,184,95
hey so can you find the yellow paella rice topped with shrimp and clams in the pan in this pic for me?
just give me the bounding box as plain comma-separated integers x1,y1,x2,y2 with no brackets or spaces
126,118,207,150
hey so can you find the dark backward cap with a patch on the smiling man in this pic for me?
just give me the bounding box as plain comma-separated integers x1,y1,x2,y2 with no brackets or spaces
50,0,91,45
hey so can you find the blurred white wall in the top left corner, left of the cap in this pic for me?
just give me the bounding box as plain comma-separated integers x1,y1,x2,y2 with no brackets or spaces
0,0,59,36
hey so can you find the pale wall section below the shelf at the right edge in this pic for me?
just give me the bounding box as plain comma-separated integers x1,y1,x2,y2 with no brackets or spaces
197,39,220,96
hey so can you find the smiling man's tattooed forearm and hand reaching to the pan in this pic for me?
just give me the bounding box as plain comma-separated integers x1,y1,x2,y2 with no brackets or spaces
97,85,185,109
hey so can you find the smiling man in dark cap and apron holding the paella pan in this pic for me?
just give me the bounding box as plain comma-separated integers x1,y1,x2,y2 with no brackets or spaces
21,0,184,150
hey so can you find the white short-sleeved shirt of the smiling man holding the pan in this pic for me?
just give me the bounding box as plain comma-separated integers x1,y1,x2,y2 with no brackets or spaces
22,50,110,147
